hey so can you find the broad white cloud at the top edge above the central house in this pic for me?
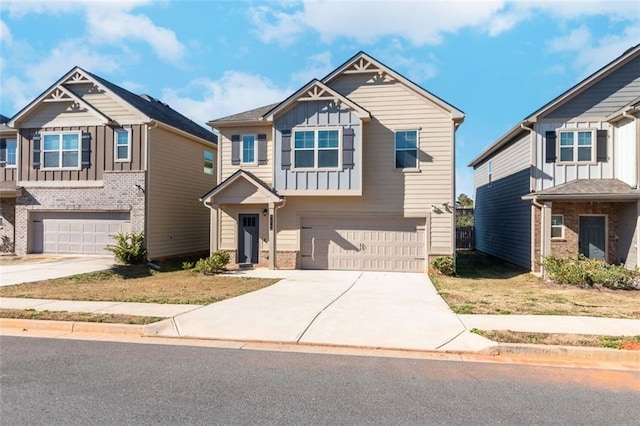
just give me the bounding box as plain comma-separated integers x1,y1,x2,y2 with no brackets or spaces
249,0,503,46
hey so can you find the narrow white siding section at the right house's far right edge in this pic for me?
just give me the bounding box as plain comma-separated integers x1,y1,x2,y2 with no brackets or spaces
613,116,640,187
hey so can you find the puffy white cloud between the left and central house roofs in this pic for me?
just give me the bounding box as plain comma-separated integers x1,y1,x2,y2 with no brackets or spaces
161,71,290,125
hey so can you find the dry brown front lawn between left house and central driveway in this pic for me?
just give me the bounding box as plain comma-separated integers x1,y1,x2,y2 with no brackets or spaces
0,261,278,305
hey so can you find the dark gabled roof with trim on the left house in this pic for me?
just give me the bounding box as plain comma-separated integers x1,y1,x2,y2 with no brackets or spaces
10,66,217,143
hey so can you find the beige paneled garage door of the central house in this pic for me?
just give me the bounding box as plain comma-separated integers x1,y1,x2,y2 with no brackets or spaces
302,218,425,272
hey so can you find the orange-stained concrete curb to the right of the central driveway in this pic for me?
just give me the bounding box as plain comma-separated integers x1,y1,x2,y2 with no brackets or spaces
478,343,640,362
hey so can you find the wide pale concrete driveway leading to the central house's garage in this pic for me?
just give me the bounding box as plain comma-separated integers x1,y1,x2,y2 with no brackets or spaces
147,270,493,350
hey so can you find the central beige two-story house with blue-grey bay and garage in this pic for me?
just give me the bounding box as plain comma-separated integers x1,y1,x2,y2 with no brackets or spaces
202,52,464,272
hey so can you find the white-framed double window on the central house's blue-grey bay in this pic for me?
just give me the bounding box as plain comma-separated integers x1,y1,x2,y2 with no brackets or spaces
293,129,340,169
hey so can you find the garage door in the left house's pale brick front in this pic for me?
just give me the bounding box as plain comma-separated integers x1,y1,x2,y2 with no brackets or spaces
31,212,130,254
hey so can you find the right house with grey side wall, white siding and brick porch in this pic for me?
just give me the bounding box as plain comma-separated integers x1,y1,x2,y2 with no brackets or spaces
470,45,640,271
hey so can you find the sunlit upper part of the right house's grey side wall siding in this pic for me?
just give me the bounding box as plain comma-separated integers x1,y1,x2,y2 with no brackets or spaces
474,132,531,188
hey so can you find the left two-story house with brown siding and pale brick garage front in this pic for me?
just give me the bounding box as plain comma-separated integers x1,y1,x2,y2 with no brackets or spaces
2,67,217,259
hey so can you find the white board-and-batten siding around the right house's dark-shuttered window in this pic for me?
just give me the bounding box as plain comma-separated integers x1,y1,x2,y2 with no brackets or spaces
534,120,615,191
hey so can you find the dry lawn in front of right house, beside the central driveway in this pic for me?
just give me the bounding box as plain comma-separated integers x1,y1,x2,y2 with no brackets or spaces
431,251,640,318
